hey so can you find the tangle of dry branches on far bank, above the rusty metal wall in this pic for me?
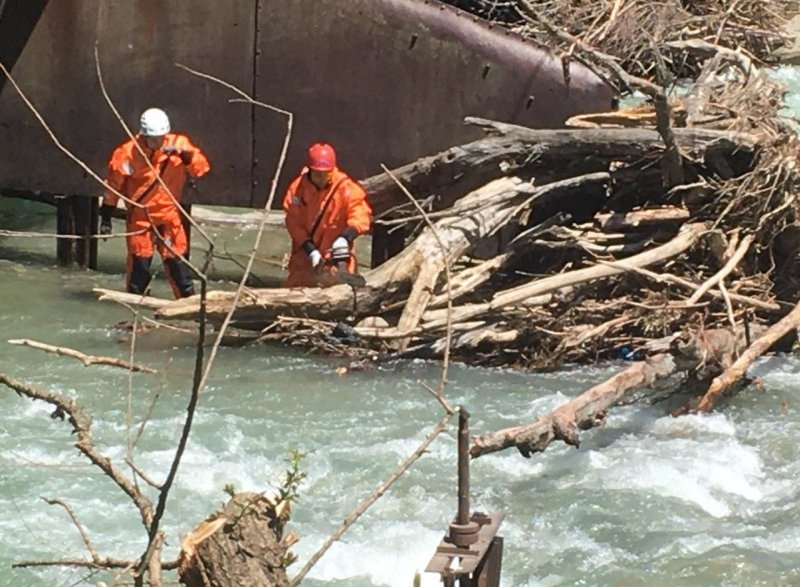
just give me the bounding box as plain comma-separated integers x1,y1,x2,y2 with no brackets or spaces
447,0,800,77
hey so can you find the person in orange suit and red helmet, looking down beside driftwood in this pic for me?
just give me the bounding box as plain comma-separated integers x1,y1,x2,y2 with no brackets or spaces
283,143,372,287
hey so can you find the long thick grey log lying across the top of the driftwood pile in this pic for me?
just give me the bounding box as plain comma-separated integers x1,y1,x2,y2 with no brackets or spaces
364,118,758,217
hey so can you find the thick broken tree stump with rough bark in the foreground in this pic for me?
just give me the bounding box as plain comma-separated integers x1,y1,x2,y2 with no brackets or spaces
178,493,291,587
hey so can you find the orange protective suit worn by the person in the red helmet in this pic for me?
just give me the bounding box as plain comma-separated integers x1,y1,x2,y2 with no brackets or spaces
283,167,372,287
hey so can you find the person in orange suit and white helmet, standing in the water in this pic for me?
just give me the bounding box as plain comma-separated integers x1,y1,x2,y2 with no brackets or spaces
100,108,210,298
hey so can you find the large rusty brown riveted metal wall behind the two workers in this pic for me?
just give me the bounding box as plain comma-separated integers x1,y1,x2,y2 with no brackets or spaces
0,0,614,207
